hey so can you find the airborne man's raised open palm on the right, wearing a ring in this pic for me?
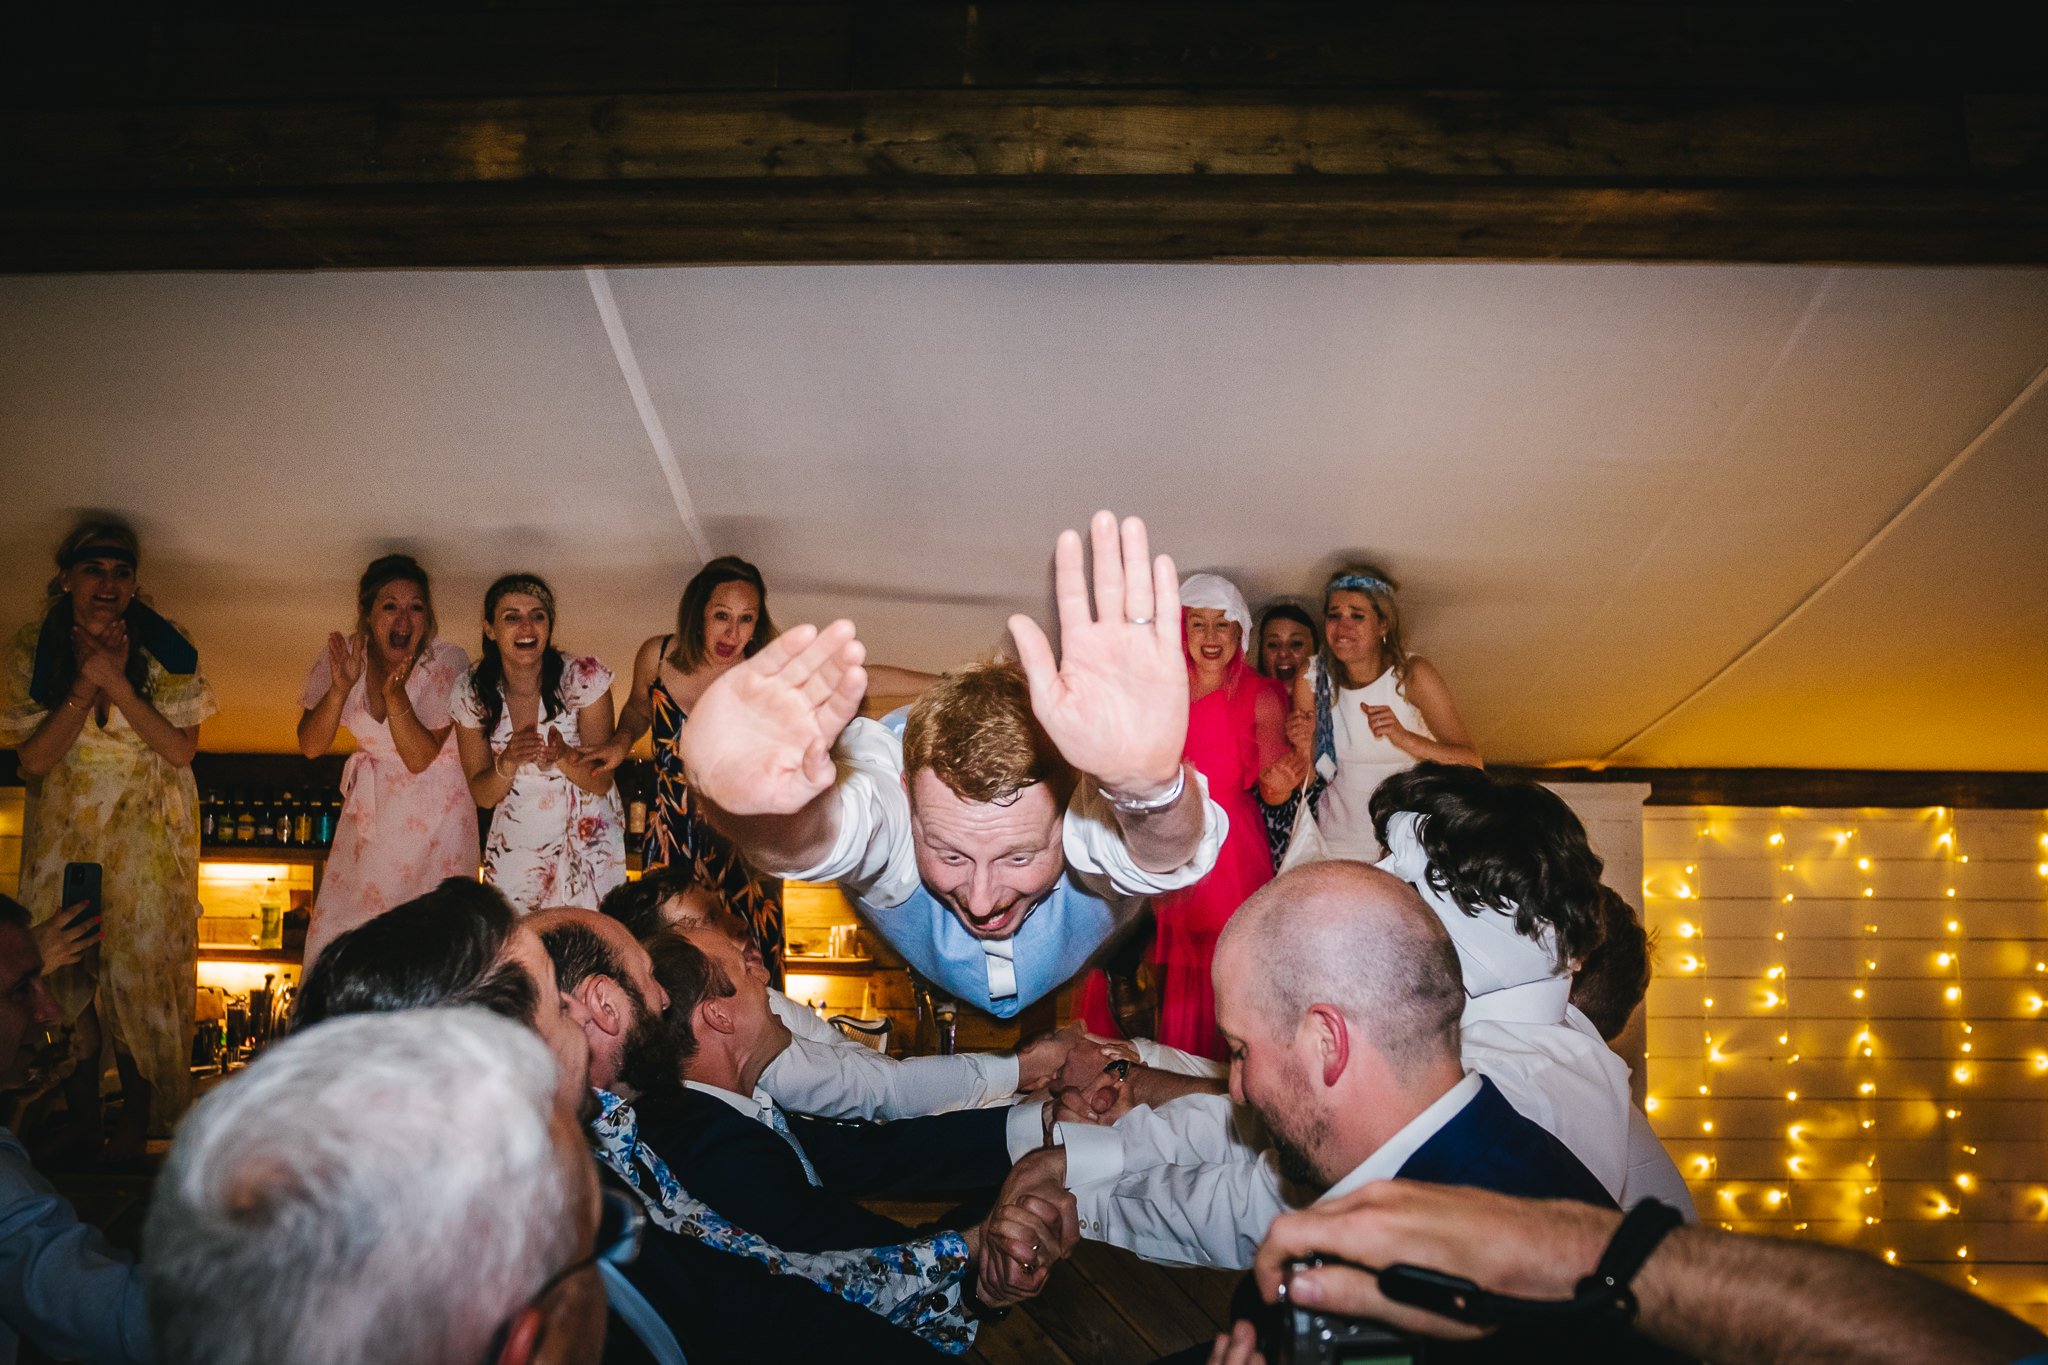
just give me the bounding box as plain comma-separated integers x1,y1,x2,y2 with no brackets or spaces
1010,512,1188,800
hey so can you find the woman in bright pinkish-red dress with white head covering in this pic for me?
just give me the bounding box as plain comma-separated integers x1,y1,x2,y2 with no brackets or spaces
1081,573,1288,1060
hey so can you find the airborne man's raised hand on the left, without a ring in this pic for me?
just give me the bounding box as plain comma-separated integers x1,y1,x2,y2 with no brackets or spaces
680,620,868,814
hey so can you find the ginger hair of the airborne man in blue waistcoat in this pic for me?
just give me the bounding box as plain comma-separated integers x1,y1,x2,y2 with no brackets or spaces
903,659,1073,802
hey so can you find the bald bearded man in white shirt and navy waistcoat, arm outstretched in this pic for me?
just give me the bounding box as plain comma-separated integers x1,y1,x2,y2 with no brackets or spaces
1014,862,1614,1267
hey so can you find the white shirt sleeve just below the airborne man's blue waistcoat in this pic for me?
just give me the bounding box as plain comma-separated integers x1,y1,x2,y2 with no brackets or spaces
762,990,1036,1121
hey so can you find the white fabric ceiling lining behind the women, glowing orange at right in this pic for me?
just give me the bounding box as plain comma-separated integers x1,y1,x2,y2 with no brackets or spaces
0,264,2048,769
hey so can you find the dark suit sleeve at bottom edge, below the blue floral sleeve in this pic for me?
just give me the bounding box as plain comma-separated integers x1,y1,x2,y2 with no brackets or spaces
627,1228,956,1365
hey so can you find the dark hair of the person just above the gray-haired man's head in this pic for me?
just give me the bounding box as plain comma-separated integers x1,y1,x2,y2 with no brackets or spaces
293,876,539,1029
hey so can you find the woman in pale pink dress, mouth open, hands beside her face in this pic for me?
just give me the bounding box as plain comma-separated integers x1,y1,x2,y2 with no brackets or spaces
299,555,477,966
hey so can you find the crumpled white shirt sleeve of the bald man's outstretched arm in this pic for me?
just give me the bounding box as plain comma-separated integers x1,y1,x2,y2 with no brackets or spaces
1069,1095,1307,1271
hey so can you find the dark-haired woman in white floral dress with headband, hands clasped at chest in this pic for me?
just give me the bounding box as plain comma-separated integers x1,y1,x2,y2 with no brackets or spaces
449,573,627,913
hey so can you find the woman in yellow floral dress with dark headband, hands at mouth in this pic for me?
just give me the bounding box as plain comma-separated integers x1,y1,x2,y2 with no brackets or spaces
0,522,215,1158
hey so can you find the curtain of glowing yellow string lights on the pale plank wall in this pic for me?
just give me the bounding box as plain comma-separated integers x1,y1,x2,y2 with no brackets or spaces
1645,806,2048,1302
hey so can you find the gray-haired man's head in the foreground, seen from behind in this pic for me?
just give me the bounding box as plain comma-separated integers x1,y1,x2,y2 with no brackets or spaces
143,1009,606,1365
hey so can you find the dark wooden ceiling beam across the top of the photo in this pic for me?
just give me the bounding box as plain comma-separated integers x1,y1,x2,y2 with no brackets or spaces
0,2,2048,270
